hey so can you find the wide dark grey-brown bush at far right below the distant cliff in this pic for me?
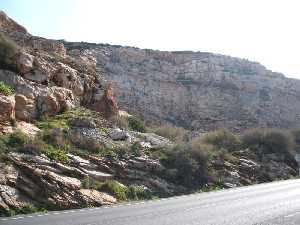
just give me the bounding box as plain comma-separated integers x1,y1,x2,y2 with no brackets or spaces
242,129,294,155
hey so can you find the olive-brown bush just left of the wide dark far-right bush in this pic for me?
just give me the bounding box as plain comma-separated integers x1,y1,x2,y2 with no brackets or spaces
201,130,241,151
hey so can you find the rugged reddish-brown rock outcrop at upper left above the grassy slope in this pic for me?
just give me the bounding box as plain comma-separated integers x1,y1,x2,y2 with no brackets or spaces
0,11,118,121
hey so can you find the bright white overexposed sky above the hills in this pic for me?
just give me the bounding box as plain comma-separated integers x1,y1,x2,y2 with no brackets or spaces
0,0,300,79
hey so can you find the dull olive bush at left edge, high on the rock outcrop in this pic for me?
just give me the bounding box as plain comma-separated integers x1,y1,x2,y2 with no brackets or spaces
0,32,20,71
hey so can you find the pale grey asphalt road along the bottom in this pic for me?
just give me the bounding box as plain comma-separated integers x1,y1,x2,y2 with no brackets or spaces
0,179,300,225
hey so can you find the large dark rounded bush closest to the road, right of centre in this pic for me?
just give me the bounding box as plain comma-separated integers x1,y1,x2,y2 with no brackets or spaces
161,143,208,187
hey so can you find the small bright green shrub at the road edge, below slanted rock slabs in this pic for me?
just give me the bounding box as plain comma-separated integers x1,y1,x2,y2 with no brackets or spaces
98,180,126,201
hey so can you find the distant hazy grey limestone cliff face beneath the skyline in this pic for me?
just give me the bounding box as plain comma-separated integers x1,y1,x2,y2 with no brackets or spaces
66,43,300,131
